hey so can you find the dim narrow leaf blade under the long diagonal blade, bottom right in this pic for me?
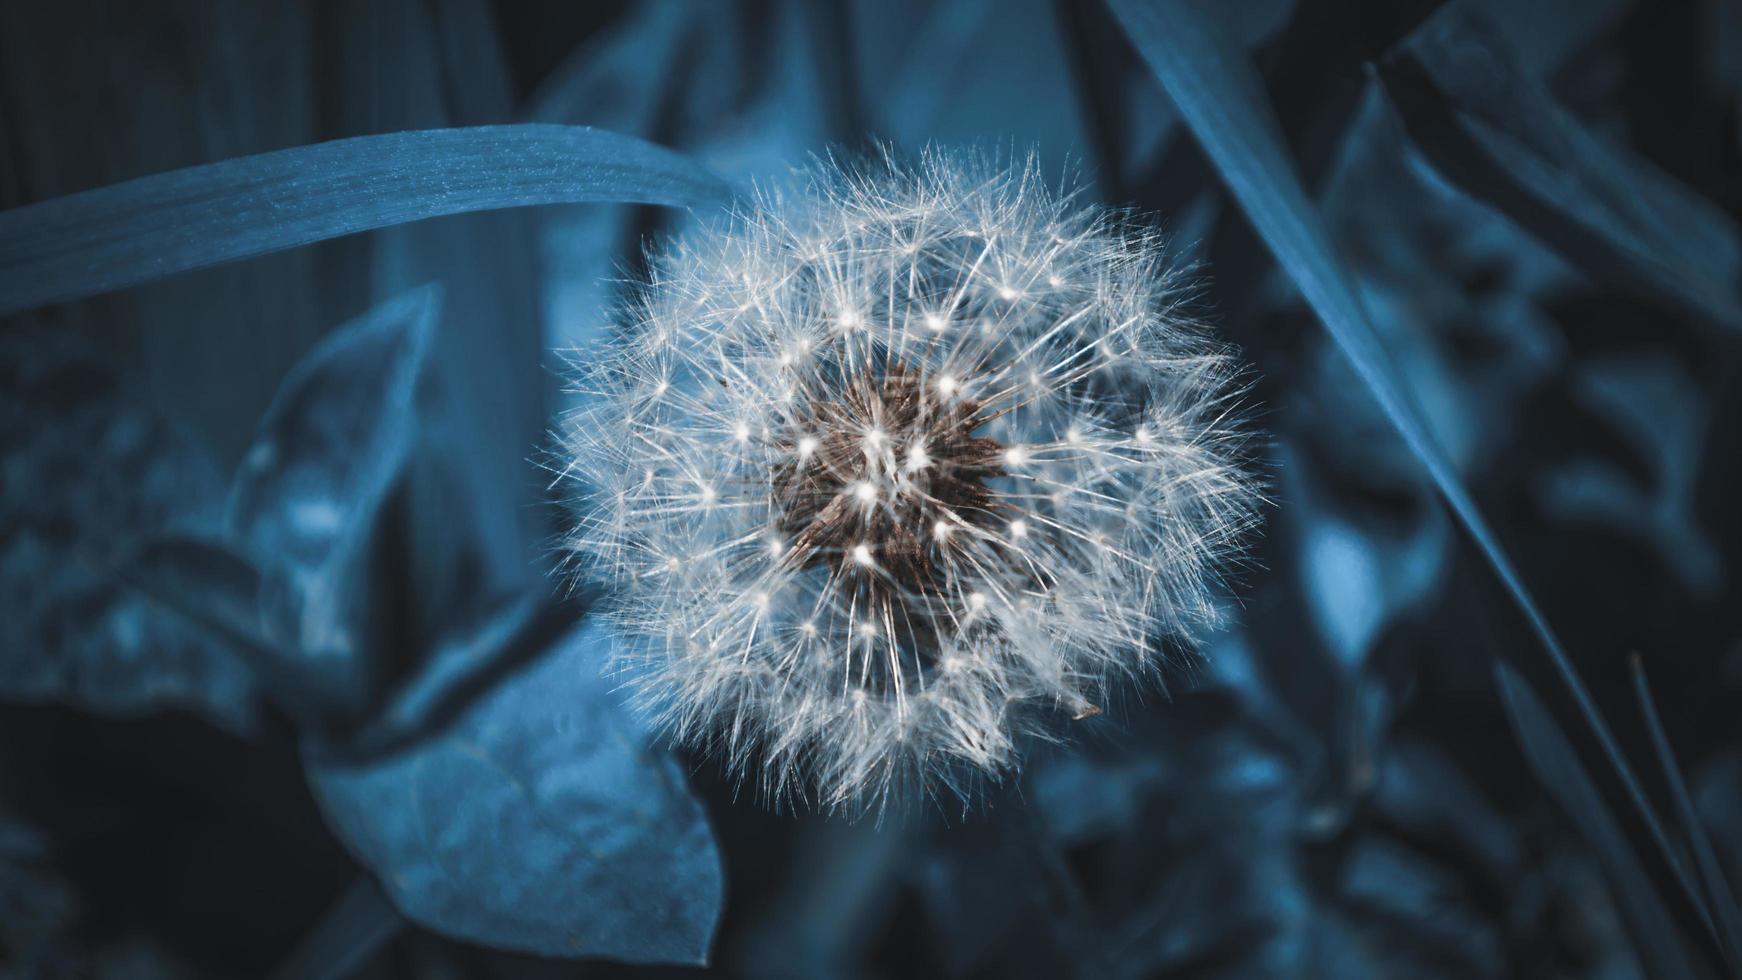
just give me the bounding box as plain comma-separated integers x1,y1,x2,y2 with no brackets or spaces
1495,661,1698,977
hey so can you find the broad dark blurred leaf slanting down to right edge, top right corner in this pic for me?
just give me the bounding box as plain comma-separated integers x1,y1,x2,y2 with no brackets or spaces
1381,3,1742,329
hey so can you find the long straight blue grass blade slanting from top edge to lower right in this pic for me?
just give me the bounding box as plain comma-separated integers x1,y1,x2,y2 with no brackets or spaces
1108,0,1716,954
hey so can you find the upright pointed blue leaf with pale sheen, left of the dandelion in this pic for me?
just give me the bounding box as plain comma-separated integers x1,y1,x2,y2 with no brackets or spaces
226,287,441,717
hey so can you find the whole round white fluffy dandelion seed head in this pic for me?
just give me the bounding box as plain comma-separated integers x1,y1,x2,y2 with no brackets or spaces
563,153,1258,808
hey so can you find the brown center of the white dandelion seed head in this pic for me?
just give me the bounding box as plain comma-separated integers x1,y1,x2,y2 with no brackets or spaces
773,364,1003,594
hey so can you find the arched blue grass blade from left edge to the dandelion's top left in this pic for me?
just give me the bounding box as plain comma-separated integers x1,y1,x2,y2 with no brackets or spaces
0,124,728,317
